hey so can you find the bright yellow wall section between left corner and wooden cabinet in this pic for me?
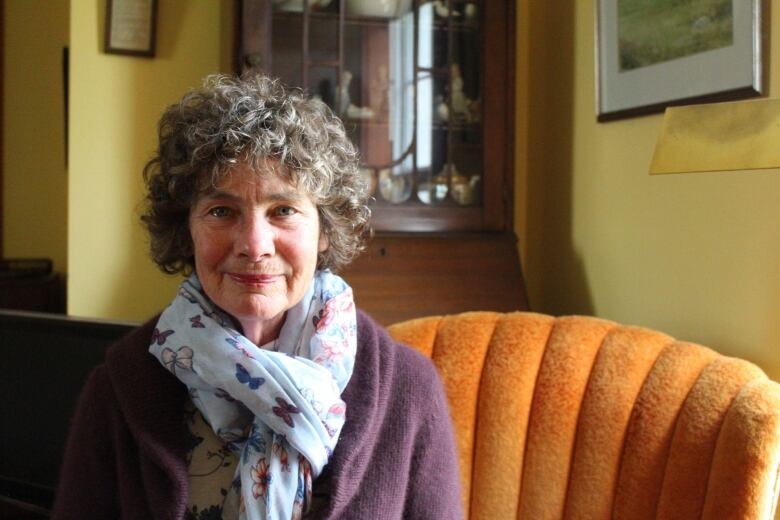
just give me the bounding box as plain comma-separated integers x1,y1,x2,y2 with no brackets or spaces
68,0,232,320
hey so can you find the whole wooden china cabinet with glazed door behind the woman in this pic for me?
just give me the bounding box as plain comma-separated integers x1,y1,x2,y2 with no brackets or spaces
236,0,527,324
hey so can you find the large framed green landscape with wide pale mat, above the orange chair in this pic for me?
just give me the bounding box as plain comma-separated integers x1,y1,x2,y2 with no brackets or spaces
596,0,763,121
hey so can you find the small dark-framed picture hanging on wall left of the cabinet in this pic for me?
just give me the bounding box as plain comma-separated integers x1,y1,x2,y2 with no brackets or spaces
105,0,157,57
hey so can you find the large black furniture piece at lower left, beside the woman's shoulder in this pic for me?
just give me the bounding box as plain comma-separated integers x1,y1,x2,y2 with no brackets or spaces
0,310,135,518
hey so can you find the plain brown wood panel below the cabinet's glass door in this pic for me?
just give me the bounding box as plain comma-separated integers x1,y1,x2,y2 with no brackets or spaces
342,233,528,325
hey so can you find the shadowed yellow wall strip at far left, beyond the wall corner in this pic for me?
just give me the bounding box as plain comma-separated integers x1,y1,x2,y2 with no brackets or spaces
1,0,70,271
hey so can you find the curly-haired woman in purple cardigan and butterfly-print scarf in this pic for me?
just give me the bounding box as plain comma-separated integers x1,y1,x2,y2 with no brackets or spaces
54,76,461,519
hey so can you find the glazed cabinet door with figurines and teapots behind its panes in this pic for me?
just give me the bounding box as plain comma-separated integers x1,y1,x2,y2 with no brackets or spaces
241,0,507,231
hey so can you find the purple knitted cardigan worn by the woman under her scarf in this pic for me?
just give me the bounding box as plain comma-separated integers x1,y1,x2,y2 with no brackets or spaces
53,312,463,520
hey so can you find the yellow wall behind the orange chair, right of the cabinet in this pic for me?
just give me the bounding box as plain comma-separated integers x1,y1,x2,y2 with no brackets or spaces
516,0,780,380
